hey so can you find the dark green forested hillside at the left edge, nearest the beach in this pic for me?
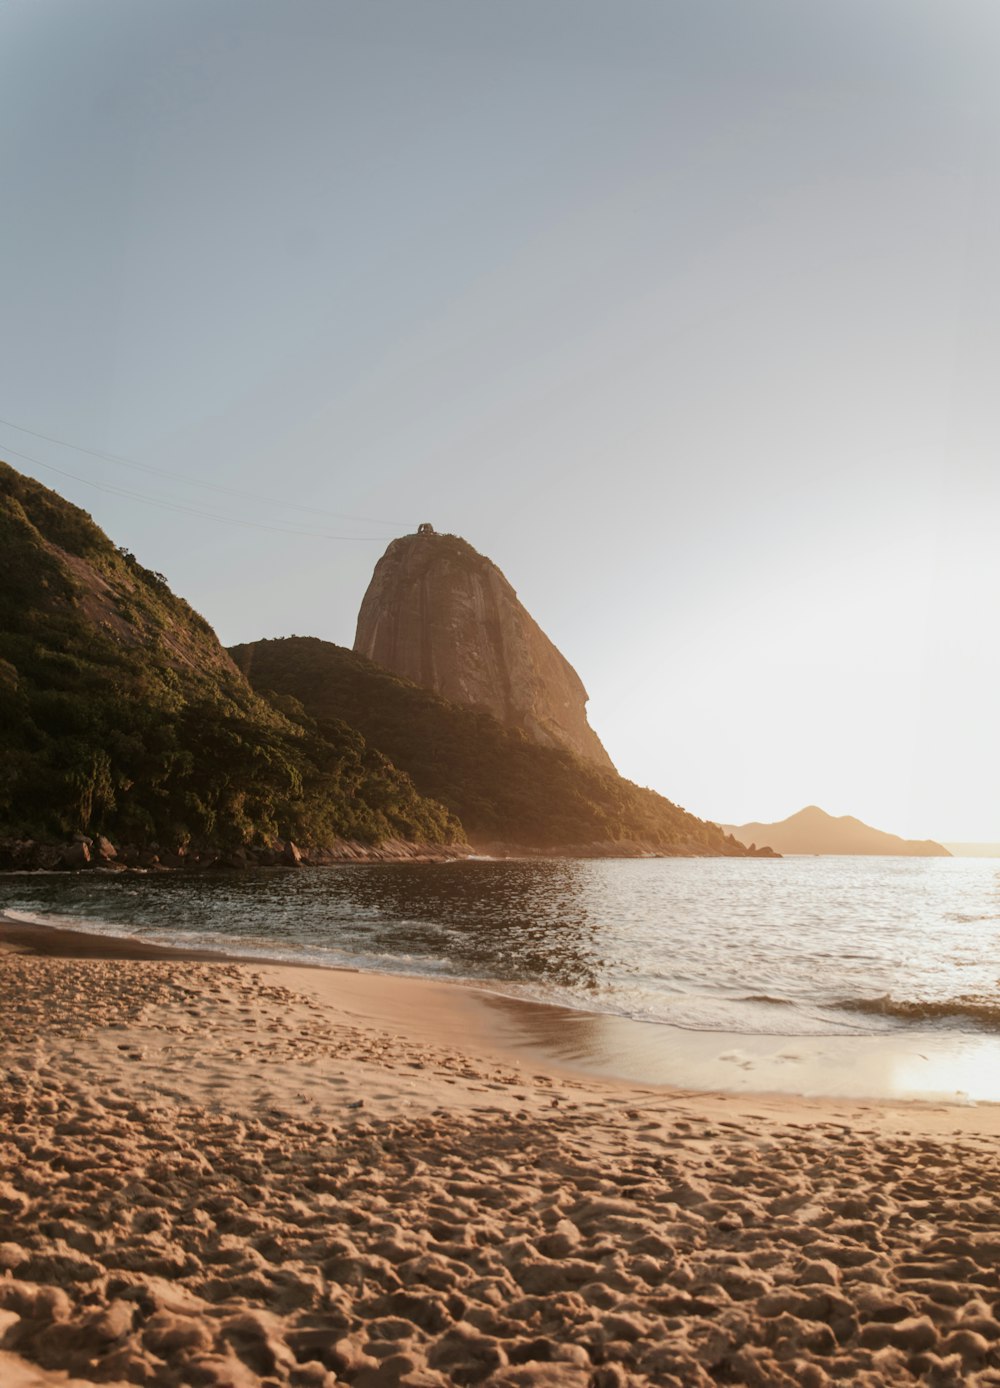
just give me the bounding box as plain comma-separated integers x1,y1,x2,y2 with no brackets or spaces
0,464,461,866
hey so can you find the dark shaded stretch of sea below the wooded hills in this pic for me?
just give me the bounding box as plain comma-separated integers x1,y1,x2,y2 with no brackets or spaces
0,861,607,994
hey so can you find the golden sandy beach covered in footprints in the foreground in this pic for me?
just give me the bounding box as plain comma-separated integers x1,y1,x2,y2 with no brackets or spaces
0,924,1000,1388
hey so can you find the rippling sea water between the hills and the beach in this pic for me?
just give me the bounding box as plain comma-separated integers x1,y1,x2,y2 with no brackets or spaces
0,858,1000,1037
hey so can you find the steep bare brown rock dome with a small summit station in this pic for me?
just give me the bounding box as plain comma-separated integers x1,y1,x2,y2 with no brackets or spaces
354,525,614,770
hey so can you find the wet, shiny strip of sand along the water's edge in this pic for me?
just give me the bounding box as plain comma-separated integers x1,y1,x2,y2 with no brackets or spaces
0,913,1000,1112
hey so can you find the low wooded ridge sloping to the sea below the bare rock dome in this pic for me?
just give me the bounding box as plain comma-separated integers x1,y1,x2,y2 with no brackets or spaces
231,636,769,858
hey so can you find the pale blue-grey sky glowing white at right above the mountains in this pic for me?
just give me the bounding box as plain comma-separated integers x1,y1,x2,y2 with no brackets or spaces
0,0,1000,841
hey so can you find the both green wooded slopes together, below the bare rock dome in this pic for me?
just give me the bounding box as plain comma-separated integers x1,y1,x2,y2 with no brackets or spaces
0,464,761,855
